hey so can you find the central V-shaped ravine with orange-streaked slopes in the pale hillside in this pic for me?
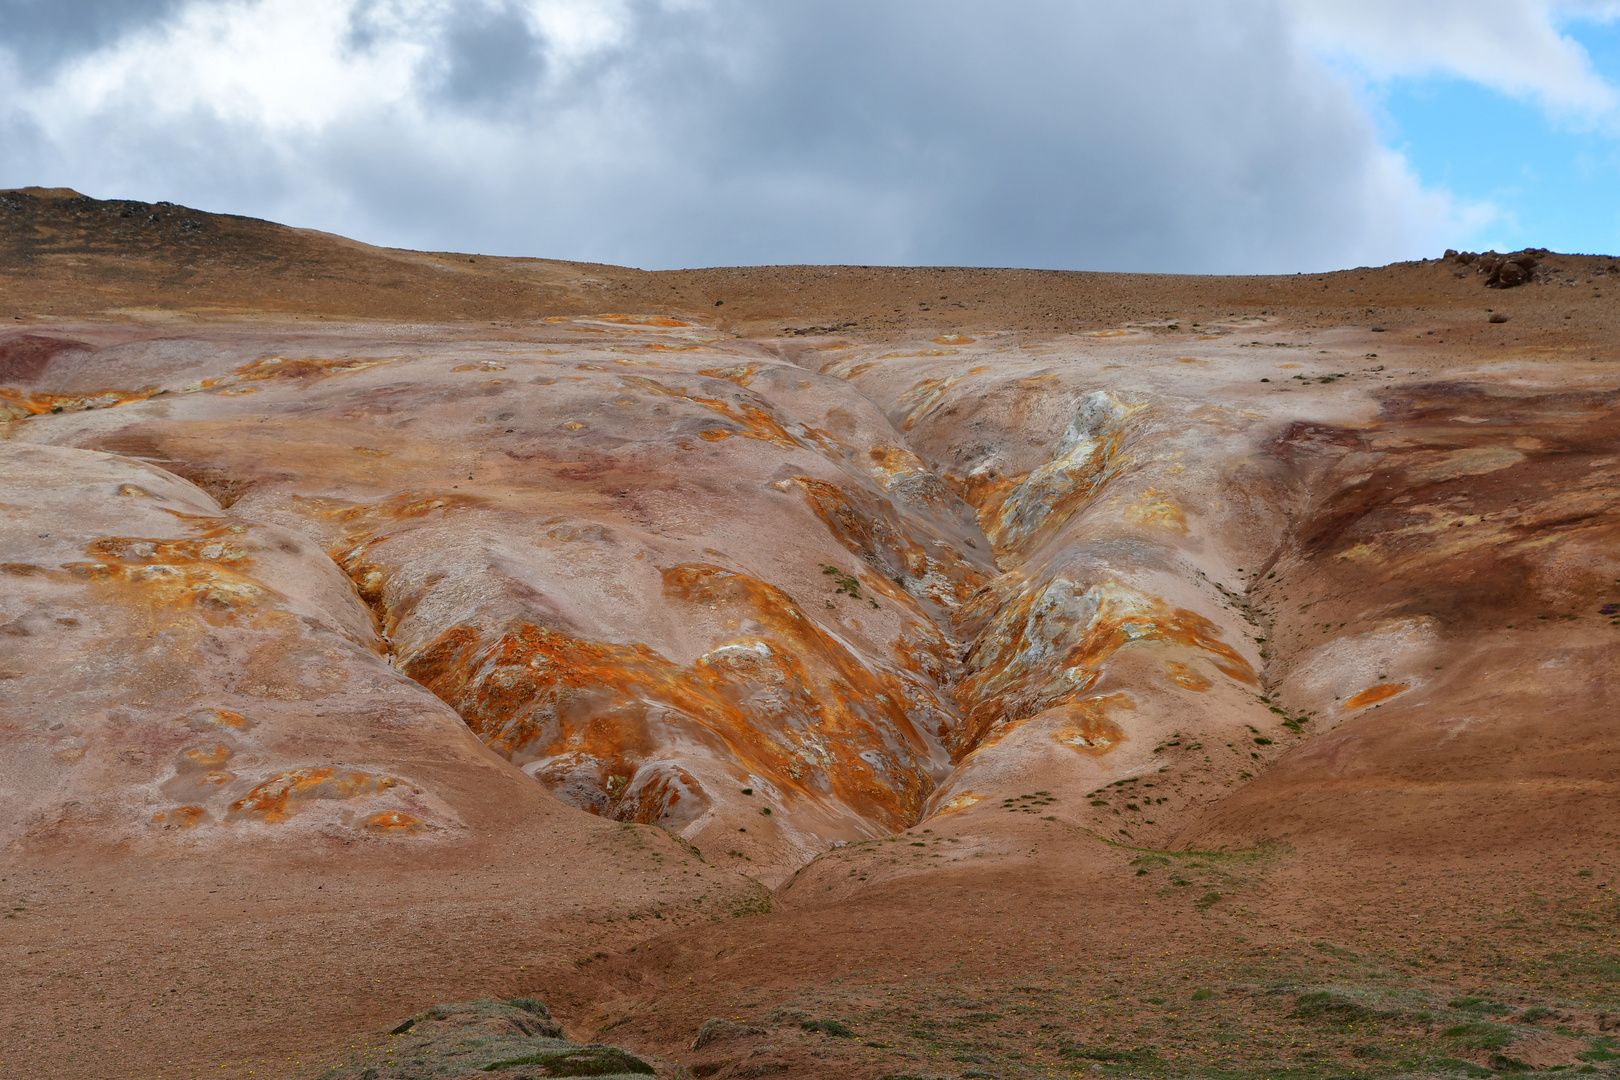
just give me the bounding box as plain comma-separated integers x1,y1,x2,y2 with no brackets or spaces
305,327,1289,881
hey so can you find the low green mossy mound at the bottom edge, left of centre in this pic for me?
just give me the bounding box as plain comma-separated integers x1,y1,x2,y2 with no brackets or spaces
322,997,653,1080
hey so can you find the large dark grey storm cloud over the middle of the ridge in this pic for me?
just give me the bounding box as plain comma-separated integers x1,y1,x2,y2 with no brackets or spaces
322,0,1425,270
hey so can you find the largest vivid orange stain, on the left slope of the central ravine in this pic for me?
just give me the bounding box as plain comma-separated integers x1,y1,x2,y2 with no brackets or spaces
400,563,933,827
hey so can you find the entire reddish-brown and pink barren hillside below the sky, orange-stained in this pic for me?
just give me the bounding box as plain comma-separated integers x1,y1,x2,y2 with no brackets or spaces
0,189,1620,1080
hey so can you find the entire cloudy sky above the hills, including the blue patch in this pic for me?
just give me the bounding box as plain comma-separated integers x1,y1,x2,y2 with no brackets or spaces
0,0,1620,272
